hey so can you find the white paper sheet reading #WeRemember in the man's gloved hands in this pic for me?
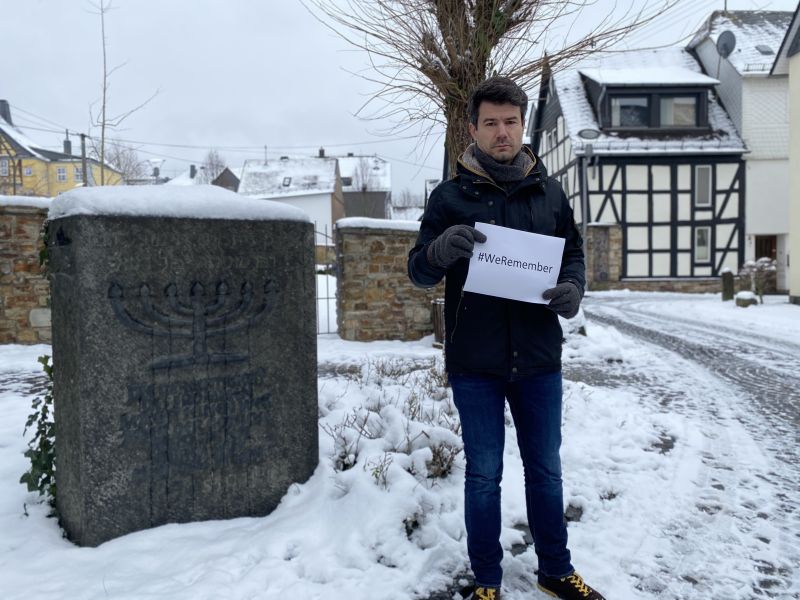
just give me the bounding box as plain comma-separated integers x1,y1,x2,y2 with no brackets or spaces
464,223,564,304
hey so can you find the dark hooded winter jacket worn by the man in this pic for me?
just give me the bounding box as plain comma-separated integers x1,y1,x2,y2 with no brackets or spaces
408,147,585,377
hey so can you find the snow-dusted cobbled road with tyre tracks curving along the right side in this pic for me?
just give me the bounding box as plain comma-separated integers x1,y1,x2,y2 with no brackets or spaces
567,295,800,598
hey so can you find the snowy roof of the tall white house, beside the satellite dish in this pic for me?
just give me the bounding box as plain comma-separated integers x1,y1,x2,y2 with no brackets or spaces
687,10,792,76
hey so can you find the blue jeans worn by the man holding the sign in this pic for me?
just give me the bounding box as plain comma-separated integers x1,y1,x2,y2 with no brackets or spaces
450,371,573,587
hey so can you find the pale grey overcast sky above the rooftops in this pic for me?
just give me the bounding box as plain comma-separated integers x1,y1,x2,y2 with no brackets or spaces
0,0,797,193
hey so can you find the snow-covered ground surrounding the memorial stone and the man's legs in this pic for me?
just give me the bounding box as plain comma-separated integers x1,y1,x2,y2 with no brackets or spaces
0,293,800,600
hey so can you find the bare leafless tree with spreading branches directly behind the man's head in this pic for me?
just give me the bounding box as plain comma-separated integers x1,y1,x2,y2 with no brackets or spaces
301,0,680,173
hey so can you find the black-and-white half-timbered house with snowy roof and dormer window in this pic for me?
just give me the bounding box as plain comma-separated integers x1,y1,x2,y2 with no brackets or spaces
528,48,746,290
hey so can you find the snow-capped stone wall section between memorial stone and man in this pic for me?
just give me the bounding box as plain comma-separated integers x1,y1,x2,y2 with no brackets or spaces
336,218,444,341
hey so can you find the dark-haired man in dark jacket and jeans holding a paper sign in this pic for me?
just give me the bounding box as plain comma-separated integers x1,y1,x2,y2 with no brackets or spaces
408,77,603,600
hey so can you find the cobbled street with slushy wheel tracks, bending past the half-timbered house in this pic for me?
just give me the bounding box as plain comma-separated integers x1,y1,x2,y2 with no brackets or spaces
565,296,800,598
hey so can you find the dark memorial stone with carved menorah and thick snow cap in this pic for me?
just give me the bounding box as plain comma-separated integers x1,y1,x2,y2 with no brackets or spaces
49,186,318,546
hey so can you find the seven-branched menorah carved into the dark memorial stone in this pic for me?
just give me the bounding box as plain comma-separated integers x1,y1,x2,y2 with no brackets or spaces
108,279,278,369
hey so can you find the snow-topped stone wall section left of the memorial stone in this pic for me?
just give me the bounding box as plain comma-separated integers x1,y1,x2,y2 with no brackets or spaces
0,196,51,344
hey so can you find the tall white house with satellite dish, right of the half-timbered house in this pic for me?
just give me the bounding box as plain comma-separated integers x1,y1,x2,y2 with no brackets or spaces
688,11,792,290
